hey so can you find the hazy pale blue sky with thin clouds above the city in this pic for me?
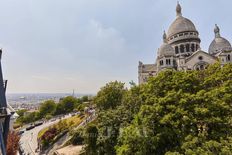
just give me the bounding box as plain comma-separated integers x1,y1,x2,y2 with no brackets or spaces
0,0,232,94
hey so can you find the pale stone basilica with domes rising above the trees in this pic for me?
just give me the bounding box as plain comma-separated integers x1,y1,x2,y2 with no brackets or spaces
138,3,232,84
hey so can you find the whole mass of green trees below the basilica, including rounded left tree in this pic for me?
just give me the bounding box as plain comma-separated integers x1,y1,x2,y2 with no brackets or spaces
85,64,232,155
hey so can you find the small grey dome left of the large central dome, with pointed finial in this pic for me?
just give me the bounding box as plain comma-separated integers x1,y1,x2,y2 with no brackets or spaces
158,32,175,57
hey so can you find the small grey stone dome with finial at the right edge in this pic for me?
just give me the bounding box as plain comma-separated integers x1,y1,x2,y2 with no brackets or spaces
209,25,231,54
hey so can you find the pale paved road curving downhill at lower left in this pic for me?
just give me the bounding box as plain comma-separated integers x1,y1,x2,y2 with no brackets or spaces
20,115,71,155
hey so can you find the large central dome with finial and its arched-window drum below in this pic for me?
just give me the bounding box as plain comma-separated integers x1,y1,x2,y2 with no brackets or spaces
167,3,201,56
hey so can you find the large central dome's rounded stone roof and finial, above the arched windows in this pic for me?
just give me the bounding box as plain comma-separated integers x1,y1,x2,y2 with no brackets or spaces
168,3,197,38
